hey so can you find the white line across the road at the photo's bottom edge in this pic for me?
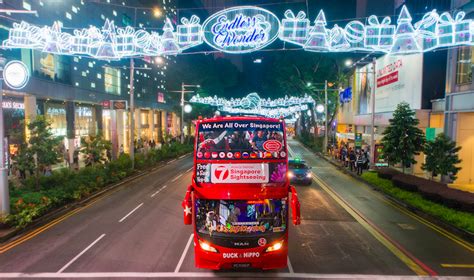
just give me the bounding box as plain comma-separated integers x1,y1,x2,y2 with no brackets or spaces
0,272,456,280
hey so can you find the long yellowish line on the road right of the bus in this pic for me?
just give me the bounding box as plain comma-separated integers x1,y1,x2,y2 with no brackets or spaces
312,172,438,276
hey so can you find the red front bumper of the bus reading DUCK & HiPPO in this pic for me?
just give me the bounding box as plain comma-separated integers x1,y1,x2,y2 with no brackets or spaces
194,241,288,270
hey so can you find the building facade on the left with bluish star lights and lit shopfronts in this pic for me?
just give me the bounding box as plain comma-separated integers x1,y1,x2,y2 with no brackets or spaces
0,0,180,162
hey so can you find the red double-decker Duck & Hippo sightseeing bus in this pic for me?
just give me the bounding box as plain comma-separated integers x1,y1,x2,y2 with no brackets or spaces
182,117,300,270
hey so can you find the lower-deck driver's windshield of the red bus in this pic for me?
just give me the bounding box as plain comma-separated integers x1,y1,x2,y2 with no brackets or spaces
195,198,287,236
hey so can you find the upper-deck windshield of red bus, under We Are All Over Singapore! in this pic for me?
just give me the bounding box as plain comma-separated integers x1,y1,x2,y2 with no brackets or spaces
196,120,286,160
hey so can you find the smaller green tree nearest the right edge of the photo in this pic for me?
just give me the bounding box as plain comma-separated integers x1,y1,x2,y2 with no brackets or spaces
421,133,461,181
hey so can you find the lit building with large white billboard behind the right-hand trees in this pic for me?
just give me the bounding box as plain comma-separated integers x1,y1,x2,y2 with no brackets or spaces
336,54,429,174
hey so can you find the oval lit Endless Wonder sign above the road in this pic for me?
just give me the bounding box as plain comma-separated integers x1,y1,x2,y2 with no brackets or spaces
202,6,280,53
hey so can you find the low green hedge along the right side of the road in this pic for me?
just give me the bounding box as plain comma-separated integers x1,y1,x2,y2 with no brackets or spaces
361,172,474,233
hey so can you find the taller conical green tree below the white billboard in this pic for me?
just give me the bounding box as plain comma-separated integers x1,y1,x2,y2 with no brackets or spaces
382,102,425,173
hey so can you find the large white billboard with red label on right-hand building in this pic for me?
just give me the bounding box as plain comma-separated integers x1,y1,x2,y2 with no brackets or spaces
354,54,423,115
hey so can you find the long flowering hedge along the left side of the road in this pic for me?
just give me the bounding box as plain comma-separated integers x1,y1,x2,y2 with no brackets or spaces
4,143,193,228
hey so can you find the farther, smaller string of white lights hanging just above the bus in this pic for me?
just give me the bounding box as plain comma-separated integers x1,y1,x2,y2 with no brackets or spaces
189,92,314,118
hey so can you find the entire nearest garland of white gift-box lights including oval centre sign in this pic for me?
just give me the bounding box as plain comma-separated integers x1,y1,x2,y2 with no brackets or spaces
2,6,474,60
